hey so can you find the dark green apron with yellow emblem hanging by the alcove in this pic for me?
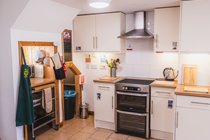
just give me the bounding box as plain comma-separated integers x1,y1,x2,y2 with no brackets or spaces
16,48,34,126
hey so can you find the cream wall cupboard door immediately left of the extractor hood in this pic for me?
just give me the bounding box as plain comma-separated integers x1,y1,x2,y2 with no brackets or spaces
96,13,121,52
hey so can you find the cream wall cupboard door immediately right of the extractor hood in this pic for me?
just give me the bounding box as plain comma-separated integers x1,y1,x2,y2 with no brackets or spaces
154,7,180,52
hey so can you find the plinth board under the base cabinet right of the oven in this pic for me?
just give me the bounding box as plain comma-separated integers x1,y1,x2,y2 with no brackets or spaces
151,130,173,140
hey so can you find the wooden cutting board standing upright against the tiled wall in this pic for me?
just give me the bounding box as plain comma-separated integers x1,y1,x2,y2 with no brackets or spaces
182,64,197,85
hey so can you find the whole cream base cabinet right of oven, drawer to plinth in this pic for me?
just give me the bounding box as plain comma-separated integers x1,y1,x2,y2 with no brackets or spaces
151,87,175,140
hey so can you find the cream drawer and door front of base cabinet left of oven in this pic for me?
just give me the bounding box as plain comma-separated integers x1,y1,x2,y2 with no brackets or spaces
94,85,114,122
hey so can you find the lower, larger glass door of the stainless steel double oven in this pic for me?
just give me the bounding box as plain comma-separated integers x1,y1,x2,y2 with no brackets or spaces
116,110,149,138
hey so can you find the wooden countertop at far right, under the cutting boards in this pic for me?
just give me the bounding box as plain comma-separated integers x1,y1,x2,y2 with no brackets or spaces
175,85,210,98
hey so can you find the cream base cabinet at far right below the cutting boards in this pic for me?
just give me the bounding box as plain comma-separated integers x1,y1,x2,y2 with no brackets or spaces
175,96,210,140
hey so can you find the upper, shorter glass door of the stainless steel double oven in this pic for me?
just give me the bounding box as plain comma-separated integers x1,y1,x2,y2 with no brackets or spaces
116,91,149,113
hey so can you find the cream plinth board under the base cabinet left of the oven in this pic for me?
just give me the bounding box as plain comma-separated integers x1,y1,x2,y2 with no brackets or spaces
94,120,115,130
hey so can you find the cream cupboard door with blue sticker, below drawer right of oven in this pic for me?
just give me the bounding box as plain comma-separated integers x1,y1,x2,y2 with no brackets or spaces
151,97,175,133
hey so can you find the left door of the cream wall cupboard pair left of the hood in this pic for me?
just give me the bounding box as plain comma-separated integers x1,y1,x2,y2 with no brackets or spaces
74,15,95,51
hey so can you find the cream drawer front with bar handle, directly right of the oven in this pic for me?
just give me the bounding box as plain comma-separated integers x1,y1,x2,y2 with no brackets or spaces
151,87,175,98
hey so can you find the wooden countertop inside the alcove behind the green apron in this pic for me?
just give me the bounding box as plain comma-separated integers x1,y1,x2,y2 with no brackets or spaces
30,78,55,88
